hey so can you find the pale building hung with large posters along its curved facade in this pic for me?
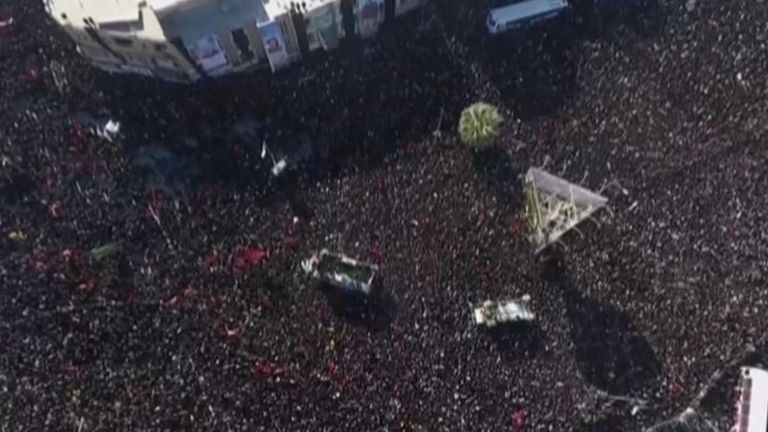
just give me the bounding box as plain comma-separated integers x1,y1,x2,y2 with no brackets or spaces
44,0,426,82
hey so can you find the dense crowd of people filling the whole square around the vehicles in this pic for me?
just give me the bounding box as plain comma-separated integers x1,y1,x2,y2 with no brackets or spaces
0,0,768,431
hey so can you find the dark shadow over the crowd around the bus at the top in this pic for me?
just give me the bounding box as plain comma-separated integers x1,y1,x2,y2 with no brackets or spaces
437,0,664,120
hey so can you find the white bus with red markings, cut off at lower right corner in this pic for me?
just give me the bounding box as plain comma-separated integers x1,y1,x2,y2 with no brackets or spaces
731,367,768,432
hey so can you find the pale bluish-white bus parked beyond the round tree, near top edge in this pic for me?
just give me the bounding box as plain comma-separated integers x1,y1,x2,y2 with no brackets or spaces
486,0,568,34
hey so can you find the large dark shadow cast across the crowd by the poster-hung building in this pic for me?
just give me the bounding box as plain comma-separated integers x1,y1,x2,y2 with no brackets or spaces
82,13,456,197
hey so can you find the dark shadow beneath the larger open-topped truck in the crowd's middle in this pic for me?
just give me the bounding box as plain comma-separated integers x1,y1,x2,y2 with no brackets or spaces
320,283,397,331
